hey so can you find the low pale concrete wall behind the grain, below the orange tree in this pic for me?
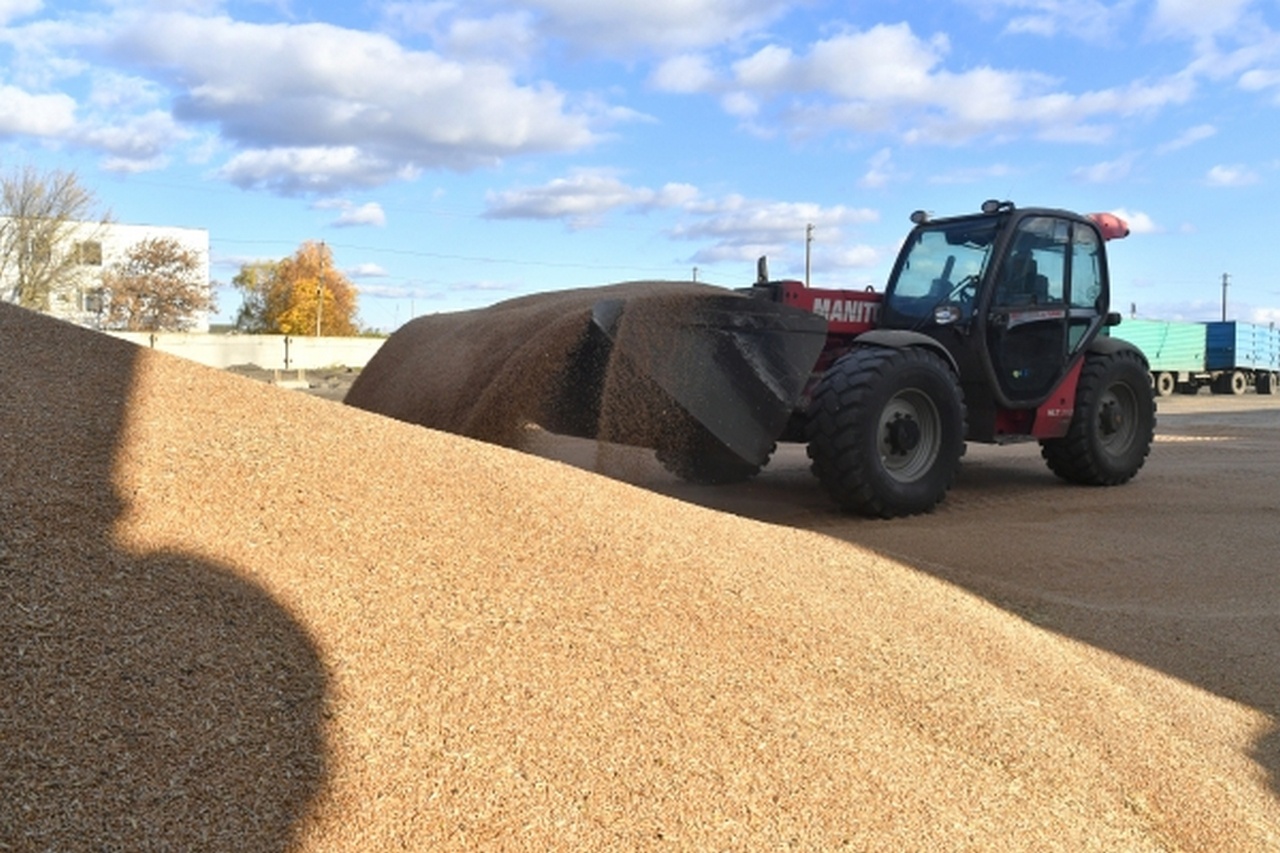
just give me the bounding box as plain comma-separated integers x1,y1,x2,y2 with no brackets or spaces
105,332,385,370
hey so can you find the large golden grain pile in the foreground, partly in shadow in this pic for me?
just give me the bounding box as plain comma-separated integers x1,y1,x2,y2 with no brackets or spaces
0,305,1280,852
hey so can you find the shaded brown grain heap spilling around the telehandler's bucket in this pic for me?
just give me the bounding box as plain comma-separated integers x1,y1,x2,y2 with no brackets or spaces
346,282,782,466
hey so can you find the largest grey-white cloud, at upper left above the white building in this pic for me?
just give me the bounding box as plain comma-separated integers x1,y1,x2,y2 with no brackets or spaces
98,14,596,191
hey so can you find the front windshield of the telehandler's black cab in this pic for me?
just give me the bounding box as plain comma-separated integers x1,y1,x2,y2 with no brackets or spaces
886,218,997,324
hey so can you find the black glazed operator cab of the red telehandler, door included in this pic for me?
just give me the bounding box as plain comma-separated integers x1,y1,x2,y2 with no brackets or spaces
879,201,1126,425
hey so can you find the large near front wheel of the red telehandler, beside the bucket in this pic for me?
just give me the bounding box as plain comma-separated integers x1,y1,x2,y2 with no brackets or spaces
806,347,965,519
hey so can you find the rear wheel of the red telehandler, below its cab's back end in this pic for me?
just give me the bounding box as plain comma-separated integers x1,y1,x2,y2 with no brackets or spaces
1041,350,1156,485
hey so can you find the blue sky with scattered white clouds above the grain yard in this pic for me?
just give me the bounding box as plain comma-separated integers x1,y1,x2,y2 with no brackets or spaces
0,0,1280,330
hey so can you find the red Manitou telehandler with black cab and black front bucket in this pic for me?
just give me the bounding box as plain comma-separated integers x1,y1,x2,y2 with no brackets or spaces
581,201,1156,517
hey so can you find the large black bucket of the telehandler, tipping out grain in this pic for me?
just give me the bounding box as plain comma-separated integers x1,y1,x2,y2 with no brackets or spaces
591,286,827,465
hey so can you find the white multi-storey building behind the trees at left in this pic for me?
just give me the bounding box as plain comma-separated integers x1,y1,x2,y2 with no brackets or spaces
0,222,210,332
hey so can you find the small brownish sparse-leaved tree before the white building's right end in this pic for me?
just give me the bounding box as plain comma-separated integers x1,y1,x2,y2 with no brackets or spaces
102,237,214,332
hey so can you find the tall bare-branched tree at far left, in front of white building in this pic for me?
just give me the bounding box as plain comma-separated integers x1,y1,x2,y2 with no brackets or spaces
0,165,110,311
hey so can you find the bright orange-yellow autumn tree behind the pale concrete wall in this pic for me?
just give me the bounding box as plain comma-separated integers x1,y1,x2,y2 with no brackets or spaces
232,241,360,336
